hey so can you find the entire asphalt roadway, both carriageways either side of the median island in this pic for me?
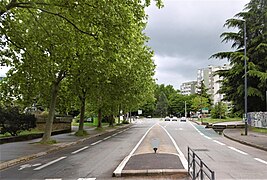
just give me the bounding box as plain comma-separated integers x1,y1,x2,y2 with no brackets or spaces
0,119,267,180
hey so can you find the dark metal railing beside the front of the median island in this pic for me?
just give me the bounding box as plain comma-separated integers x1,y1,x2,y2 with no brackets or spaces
188,147,215,180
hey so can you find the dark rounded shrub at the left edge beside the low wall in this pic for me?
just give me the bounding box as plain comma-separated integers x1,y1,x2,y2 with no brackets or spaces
0,107,36,136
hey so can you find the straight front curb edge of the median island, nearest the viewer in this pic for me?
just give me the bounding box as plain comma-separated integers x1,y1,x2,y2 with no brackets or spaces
121,169,188,177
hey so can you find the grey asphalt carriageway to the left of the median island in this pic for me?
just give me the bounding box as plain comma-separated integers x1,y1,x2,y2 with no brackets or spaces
0,123,152,180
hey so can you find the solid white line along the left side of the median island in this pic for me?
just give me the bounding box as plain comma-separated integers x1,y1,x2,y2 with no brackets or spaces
113,124,157,177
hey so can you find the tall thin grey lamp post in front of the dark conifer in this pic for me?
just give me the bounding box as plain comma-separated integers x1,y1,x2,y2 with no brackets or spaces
244,20,248,135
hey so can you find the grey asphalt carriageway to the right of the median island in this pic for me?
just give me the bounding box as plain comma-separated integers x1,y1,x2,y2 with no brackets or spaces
161,121,267,179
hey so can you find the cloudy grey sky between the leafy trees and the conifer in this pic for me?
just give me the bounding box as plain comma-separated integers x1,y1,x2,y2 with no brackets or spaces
145,0,249,89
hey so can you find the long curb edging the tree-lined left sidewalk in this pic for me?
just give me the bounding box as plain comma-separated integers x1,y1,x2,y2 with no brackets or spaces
0,124,131,170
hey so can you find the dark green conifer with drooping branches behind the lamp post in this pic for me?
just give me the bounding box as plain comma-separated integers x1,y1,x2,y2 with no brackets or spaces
212,0,267,114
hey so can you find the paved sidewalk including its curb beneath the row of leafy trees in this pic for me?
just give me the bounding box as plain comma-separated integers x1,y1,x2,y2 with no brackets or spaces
0,125,129,170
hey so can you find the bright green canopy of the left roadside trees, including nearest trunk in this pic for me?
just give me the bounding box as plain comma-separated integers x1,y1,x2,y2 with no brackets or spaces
0,0,162,142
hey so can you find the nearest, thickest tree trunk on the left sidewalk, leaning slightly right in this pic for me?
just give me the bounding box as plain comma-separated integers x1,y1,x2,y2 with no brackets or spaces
41,81,59,143
